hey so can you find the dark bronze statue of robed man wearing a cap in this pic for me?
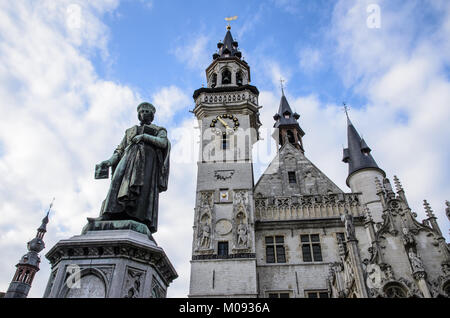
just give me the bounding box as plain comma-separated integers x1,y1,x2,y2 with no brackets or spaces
99,103,170,233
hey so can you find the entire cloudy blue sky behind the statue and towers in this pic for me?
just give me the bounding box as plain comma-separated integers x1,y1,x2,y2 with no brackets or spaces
0,0,450,297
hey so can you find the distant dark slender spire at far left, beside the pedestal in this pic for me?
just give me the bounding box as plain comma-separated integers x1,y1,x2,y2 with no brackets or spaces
5,203,53,298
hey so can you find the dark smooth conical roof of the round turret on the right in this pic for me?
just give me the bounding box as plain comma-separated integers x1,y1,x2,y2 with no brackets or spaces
342,113,384,185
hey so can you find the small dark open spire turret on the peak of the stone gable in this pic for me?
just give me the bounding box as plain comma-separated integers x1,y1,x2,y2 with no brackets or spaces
273,87,305,152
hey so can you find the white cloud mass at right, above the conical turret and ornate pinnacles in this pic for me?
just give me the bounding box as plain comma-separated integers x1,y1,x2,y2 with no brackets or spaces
331,1,450,235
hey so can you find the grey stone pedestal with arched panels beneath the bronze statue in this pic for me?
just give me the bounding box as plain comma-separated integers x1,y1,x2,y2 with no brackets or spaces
44,219,178,298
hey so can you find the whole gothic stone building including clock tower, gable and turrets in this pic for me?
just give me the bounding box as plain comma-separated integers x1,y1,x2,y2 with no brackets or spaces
188,27,450,298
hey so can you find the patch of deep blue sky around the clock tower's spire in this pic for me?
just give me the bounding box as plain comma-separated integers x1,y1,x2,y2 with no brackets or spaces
94,1,364,110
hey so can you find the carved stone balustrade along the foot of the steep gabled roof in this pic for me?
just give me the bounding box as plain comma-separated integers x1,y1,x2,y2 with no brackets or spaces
255,193,363,221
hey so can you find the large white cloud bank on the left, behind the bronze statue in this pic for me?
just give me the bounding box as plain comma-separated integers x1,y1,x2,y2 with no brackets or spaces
0,1,195,297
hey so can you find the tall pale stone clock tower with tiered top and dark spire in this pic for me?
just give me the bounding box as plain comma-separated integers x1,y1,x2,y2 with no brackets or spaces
189,26,261,297
